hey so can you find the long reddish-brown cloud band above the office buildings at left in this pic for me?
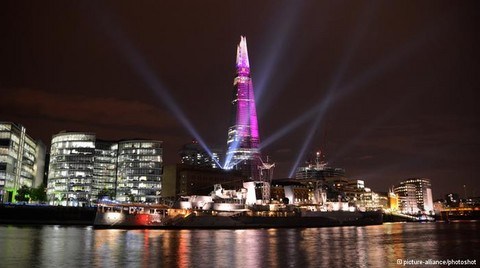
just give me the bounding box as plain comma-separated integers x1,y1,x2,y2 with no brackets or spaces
2,89,179,130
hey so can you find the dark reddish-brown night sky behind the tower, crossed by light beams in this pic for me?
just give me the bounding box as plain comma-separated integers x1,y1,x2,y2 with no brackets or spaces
0,1,480,198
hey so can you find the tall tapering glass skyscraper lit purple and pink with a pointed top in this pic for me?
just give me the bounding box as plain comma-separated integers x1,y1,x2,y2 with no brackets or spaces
225,36,261,180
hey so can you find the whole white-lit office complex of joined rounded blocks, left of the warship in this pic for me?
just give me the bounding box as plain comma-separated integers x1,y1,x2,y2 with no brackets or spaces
47,132,163,206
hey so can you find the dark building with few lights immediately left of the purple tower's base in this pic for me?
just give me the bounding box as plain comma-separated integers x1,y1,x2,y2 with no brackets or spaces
178,140,220,168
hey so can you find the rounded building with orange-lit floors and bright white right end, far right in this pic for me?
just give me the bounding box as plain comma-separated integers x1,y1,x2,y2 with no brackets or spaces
394,178,433,214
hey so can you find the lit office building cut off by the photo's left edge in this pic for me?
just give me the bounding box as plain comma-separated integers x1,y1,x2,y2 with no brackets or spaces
0,122,45,203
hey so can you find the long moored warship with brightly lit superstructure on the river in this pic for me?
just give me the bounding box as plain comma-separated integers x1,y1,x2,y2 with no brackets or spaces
94,185,383,229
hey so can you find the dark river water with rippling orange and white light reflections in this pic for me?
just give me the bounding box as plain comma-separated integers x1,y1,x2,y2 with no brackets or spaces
0,222,480,268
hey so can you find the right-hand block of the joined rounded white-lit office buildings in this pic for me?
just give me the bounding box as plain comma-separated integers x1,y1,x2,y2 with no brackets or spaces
116,140,163,203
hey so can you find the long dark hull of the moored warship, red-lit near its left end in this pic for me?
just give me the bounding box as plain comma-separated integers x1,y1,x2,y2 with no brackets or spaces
94,211,383,229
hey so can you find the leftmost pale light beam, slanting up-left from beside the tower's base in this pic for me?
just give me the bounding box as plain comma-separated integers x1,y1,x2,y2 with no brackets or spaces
88,5,221,167
